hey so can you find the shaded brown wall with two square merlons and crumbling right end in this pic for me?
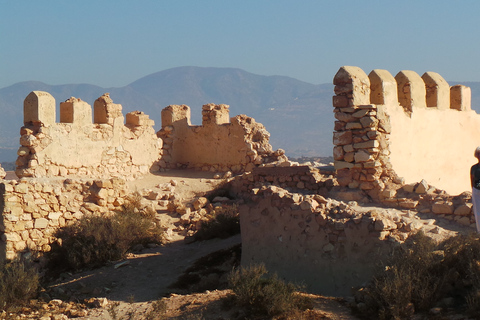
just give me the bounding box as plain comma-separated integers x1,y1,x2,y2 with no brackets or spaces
158,104,287,172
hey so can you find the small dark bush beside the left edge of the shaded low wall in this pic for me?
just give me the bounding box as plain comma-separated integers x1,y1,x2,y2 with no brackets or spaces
193,206,240,241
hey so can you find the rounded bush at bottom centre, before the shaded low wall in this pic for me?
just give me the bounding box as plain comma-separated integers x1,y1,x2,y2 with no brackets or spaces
229,265,312,316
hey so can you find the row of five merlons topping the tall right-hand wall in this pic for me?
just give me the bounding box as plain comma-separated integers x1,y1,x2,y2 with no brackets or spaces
333,66,471,113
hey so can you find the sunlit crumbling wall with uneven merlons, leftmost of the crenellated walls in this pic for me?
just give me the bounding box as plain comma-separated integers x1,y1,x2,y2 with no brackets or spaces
16,91,162,178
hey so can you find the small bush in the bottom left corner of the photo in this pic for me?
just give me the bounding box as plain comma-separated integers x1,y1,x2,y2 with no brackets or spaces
0,260,39,310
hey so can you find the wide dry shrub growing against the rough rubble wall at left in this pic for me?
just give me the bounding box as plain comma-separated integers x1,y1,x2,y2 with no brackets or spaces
49,196,163,270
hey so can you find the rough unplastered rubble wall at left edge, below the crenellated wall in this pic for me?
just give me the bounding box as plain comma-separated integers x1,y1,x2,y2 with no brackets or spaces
0,178,127,261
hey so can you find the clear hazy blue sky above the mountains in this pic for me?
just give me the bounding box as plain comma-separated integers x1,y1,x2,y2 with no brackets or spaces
0,0,480,88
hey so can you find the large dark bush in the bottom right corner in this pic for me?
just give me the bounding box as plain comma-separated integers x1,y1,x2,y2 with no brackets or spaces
357,233,480,319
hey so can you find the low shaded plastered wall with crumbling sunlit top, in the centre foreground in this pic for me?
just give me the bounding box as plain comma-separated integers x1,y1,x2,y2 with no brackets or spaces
239,185,474,296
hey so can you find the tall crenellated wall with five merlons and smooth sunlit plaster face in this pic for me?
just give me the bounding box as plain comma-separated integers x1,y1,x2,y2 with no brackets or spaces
333,66,480,195
